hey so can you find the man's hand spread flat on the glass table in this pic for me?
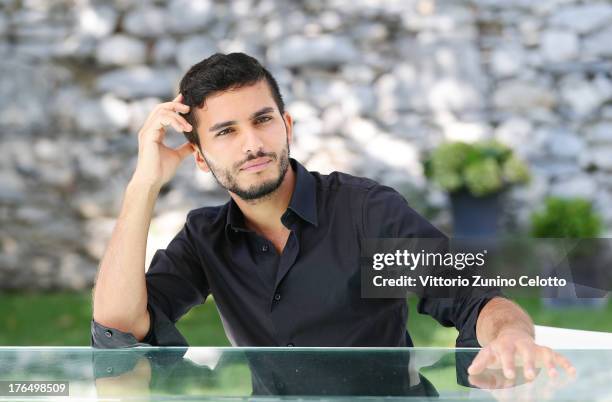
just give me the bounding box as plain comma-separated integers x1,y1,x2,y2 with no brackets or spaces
468,329,576,381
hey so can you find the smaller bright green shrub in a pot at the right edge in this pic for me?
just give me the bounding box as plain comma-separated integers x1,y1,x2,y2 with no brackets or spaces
531,197,609,307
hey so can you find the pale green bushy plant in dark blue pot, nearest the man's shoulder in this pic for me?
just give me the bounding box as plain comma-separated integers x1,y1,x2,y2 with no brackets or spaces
423,140,530,237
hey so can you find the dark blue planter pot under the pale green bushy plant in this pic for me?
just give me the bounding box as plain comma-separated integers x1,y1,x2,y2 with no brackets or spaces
450,190,502,237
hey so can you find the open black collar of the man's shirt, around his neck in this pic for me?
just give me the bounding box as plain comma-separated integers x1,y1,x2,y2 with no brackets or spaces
225,158,318,231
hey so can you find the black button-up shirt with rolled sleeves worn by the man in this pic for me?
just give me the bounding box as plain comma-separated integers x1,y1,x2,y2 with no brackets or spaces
92,159,499,347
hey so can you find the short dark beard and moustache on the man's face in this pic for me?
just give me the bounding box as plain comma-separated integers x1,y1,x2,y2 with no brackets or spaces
202,141,290,201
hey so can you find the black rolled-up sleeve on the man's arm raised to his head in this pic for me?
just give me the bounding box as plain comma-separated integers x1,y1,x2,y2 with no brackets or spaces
91,216,210,348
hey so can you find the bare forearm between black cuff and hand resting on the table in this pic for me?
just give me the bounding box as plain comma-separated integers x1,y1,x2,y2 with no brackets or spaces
476,297,535,347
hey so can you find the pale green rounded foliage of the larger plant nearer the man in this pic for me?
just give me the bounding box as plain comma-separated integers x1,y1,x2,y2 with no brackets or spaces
424,141,529,197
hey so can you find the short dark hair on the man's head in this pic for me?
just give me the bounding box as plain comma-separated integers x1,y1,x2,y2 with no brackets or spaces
179,53,285,149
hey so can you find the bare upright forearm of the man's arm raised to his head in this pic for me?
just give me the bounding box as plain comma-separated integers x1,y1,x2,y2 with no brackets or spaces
93,180,159,339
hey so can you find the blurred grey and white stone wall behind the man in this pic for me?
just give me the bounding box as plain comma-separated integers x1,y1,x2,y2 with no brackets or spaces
0,0,612,289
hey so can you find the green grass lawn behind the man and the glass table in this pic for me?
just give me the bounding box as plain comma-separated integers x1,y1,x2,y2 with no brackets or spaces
0,292,612,347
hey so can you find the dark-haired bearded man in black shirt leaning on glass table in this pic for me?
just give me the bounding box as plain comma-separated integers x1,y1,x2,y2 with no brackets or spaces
92,53,573,378
